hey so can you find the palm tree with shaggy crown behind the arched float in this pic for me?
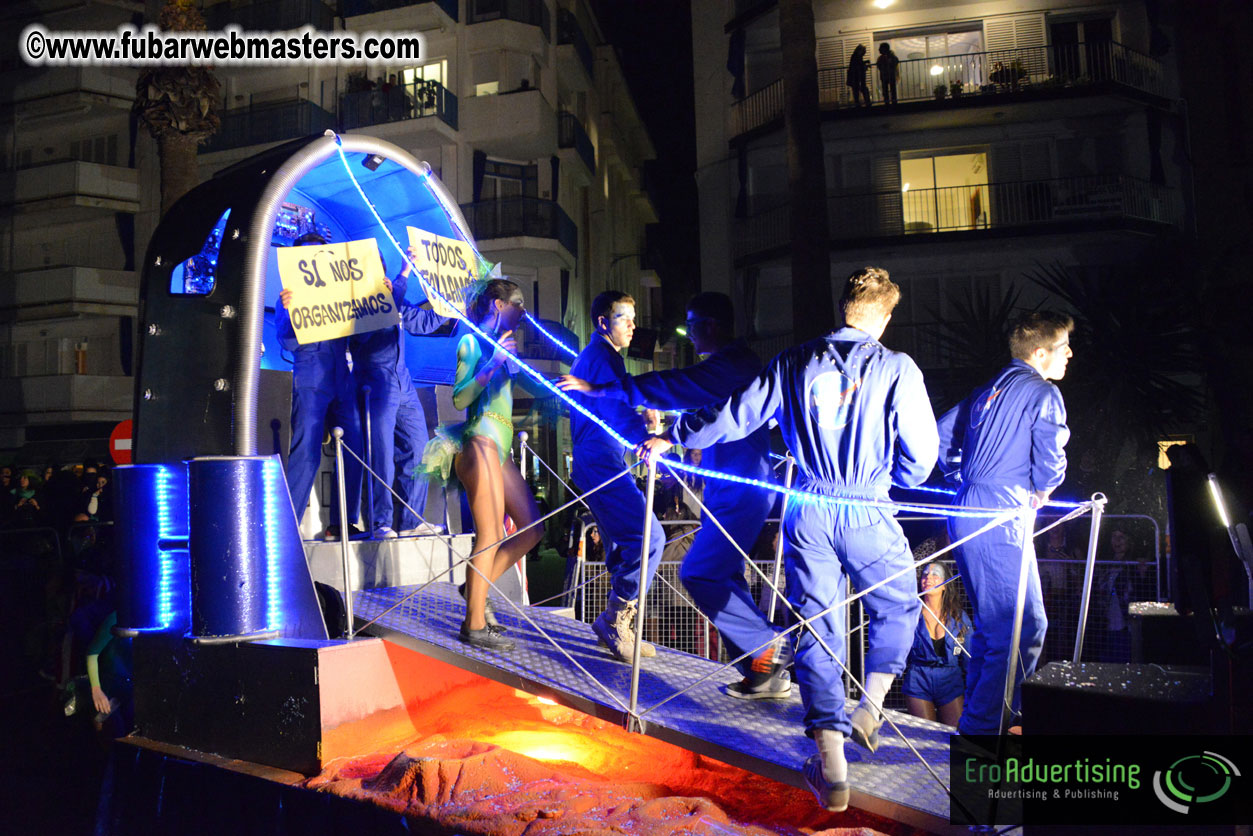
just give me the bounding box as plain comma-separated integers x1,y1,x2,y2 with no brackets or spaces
134,0,222,214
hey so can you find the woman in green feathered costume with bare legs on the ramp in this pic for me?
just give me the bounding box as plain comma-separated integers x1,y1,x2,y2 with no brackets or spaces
421,278,544,651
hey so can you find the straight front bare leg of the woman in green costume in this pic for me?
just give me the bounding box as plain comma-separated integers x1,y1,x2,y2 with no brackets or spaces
454,436,505,630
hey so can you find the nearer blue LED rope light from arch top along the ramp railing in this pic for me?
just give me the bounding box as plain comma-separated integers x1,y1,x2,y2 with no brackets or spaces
335,140,1062,519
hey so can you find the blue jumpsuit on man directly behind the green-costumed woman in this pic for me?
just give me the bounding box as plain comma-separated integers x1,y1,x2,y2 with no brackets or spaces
570,333,665,600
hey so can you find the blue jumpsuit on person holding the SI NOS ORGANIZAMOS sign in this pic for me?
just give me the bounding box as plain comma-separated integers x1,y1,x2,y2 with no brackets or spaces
274,305,365,525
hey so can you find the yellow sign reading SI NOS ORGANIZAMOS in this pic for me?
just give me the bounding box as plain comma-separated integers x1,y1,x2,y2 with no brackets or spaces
277,238,400,345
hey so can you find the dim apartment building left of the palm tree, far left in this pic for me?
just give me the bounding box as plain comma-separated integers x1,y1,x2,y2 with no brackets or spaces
0,0,155,460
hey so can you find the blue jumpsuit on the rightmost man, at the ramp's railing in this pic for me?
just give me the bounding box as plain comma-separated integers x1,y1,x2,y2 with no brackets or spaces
940,360,1070,734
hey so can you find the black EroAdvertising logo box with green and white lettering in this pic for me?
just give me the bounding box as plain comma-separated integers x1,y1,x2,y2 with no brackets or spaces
949,736,1253,825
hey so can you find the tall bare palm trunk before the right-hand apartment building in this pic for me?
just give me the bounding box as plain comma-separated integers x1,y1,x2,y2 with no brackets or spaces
779,0,834,342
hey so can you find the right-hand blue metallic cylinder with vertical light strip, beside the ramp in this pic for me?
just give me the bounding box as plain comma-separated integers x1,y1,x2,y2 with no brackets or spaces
189,456,326,639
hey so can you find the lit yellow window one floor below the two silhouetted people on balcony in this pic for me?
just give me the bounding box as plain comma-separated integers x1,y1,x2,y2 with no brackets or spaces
901,150,991,234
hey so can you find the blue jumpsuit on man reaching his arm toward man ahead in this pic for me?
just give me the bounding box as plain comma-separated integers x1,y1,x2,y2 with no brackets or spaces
609,340,774,674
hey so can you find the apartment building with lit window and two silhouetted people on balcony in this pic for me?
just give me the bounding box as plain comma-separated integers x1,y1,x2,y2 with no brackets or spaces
693,0,1189,398
